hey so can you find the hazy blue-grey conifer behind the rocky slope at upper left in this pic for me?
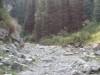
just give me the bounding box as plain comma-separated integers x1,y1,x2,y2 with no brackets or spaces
11,0,25,24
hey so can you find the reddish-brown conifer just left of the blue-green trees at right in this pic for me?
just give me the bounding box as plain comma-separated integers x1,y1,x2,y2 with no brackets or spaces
68,0,84,32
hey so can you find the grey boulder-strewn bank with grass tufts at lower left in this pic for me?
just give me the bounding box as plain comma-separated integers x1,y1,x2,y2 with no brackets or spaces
0,41,35,75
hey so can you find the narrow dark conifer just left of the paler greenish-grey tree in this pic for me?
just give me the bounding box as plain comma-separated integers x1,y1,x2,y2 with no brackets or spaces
24,0,35,34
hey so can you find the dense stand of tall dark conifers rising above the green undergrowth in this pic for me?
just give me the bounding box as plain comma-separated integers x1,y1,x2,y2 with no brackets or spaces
4,0,100,40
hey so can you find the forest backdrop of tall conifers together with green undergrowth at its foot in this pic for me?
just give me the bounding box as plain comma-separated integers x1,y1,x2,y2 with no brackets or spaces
0,0,100,45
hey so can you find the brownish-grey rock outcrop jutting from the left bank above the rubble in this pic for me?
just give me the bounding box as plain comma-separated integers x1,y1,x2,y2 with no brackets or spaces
0,20,24,47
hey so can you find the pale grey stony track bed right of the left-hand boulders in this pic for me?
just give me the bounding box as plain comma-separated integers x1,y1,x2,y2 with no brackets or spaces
20,44,100,75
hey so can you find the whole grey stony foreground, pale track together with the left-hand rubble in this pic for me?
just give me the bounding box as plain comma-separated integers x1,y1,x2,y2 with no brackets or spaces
0,43,100,75
